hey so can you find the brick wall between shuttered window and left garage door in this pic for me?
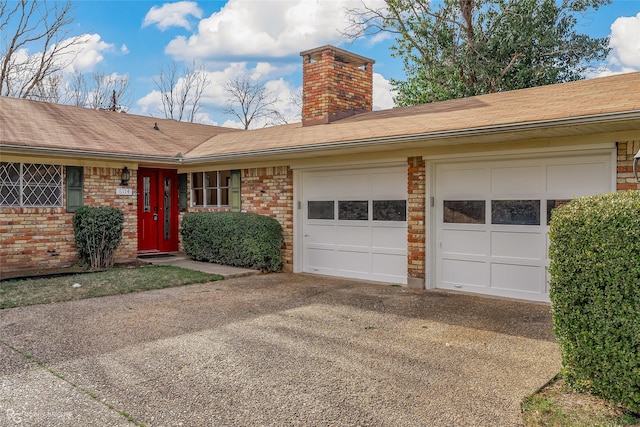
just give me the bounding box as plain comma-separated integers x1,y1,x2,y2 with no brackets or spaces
241,166,293,271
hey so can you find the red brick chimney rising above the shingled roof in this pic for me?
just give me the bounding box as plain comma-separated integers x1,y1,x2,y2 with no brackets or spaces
300,46,375,126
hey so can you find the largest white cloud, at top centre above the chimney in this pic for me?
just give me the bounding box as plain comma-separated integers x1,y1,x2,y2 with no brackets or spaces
165,0,382,60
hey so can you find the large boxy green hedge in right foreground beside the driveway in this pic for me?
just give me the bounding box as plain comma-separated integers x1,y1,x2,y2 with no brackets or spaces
549,192,640,412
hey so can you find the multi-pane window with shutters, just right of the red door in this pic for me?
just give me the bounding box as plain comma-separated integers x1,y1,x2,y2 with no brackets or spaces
191,171,231,207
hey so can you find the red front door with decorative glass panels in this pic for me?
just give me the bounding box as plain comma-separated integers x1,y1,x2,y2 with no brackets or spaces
138,168,178,252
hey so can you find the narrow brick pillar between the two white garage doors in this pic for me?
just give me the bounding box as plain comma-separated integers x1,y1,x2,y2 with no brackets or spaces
407,157,426,287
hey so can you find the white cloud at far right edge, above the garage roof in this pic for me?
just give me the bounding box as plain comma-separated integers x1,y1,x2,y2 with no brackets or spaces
610,13,640,69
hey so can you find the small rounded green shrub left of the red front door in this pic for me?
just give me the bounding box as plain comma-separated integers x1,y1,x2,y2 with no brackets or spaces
73,206,124,268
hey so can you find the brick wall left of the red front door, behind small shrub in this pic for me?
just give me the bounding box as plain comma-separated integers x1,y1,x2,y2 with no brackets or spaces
0,167,138,271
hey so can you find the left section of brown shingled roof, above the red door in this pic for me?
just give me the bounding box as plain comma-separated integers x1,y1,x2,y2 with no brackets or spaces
0,97,240,158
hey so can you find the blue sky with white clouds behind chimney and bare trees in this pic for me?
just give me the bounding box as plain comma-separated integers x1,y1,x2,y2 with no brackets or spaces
43,0,640,127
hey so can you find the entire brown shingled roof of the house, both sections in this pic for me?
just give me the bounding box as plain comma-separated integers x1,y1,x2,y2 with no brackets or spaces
0,72,640,162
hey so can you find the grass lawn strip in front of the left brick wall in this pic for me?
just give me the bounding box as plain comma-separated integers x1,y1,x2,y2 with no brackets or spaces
0,265,223,309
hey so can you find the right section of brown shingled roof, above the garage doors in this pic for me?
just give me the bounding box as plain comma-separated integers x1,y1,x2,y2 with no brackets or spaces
187,72,640,162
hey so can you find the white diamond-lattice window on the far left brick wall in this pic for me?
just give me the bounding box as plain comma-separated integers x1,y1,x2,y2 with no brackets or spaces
0,162,63,207
